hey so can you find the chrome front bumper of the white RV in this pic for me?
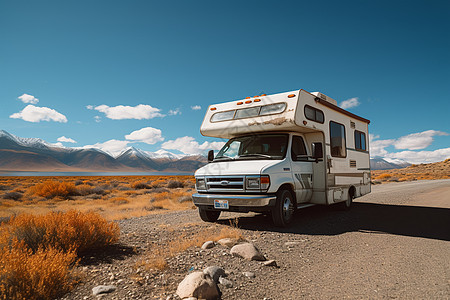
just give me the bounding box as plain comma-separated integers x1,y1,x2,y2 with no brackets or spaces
192,193,277,210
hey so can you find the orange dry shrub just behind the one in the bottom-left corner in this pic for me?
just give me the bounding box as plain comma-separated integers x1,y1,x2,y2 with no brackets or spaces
0,210,119,253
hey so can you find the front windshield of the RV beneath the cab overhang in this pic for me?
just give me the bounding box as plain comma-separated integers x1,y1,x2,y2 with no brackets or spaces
214,134,289,161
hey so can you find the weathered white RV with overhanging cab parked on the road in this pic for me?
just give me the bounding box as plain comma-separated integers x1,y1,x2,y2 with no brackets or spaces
193,90,370,226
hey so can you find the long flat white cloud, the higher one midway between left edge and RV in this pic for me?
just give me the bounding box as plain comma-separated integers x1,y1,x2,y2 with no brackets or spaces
95,104,164,120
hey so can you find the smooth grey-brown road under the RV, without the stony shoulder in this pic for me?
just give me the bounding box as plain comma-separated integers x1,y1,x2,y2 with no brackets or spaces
216,180,450,300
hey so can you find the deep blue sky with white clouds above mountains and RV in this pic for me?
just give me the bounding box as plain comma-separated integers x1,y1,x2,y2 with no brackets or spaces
0,1,450,163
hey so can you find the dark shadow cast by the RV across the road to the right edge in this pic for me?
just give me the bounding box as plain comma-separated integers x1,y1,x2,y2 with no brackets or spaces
220,202,450,241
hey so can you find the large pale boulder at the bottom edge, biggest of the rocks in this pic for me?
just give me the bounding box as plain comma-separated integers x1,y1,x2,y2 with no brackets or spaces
177,271,219,300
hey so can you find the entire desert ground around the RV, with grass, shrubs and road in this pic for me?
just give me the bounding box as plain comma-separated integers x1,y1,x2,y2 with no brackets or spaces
0,160,450,299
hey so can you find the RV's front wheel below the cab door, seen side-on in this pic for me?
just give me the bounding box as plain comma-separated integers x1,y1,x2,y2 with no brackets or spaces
272,189,295,227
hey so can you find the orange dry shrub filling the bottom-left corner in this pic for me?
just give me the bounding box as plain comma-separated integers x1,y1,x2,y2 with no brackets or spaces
0,241,76,299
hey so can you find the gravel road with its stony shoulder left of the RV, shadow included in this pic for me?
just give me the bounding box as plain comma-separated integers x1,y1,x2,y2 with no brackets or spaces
65,180,450,300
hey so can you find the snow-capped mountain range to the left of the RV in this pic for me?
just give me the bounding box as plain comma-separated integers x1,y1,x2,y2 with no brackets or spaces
0,130,206,172
